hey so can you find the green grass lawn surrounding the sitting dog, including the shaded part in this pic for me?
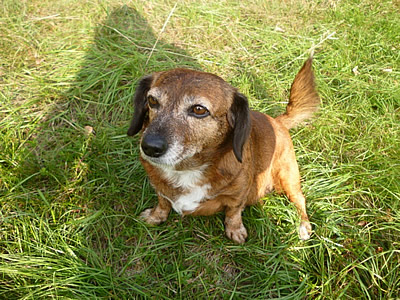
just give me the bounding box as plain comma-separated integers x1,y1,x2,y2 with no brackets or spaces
0,0,400,299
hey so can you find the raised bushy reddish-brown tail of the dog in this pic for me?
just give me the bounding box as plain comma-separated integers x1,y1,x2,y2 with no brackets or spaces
276,57,320,129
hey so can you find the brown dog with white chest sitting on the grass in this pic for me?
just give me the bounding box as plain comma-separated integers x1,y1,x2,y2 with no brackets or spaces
128,58,320,243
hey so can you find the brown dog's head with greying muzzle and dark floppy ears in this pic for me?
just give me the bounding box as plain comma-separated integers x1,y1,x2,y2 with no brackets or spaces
128,69,250,166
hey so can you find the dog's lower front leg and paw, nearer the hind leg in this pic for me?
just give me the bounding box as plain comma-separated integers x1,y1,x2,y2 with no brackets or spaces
225,205,247,244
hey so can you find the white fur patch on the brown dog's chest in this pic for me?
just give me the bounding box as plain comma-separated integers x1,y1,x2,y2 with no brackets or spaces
158,165,211,214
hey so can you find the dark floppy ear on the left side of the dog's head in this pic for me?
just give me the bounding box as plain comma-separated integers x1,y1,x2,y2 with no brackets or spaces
128,75,153,136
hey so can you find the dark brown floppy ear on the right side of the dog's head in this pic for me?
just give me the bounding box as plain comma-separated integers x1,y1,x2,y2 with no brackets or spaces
228,92,251,162
